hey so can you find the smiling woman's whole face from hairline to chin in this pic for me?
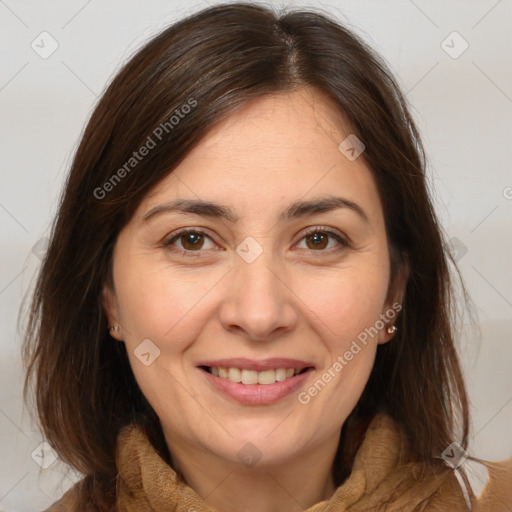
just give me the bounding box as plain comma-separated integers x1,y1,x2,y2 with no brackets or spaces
105,89,397,464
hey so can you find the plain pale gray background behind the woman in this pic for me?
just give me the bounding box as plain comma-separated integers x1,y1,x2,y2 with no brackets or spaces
0,0,512,512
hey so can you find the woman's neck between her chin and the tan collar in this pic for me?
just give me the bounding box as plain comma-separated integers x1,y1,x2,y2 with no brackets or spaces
165,434,339,512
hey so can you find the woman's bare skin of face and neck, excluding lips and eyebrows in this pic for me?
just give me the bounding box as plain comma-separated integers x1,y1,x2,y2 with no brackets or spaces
104,89,403,512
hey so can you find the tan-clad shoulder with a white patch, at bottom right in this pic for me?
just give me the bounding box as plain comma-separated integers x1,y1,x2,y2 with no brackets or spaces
428,458,512,512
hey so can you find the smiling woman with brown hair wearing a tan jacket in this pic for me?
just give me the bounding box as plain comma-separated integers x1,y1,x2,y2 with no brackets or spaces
25,4,512,512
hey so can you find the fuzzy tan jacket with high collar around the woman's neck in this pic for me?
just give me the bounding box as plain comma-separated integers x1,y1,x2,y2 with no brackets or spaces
47,414,512,512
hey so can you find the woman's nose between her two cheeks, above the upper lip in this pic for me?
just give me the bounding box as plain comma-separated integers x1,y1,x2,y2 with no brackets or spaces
219,251,298,342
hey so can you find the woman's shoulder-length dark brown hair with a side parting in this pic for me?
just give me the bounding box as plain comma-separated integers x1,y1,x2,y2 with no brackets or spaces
24,3,469,510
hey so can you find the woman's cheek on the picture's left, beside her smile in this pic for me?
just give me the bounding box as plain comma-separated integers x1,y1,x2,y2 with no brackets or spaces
115,259,214,428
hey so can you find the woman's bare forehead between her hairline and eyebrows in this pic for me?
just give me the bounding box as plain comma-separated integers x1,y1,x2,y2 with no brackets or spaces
141,89,380,222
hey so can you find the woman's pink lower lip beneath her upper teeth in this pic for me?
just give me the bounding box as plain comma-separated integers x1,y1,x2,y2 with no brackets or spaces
199,368,313,405
